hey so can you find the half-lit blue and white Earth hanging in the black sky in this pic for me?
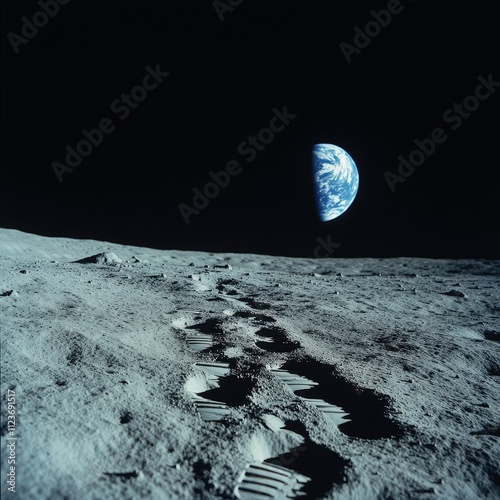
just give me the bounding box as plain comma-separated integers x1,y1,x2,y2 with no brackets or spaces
313,144,359,222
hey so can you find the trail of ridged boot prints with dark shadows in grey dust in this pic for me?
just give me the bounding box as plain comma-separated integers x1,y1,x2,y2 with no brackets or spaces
176,280,402,499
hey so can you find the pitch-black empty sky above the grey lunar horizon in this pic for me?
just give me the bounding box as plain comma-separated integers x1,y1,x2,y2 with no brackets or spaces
0,0,500,258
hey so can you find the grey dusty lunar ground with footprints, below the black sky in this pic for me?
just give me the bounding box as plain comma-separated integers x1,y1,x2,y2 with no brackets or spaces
0,229,500,500
